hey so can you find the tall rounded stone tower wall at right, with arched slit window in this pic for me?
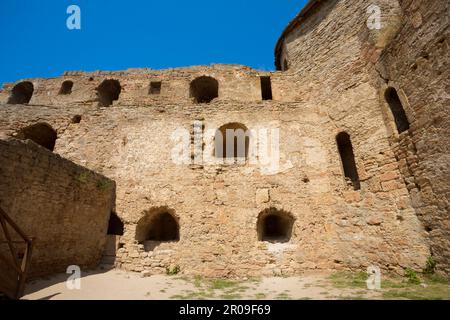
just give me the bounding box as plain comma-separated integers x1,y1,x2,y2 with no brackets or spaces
276,0,450,273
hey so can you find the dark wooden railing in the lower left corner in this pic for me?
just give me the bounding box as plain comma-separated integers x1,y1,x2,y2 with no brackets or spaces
0,208,33,299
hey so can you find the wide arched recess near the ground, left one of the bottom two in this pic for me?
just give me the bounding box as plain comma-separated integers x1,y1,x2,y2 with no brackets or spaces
136,208,180,244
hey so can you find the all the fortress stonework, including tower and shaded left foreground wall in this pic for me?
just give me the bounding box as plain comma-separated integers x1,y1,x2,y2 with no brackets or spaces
0,0,450,277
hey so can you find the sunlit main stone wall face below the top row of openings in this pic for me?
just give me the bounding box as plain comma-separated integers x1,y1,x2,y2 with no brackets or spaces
0,63,429,276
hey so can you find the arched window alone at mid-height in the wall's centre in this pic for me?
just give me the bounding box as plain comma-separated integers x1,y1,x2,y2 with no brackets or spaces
214,123,250,159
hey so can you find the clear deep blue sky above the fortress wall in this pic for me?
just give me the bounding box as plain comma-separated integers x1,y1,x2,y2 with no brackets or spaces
0,0,307,85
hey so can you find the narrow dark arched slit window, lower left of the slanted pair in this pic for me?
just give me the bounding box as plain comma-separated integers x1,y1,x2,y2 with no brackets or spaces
336,132,361,190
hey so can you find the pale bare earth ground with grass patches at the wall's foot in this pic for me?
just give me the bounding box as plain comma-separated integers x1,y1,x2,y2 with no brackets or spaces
23,269,450,300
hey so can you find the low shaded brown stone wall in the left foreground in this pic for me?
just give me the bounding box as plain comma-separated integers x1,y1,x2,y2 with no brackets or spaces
0,139,115,276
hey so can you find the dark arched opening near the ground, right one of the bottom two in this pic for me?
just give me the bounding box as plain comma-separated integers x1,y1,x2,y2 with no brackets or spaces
257,208,294,243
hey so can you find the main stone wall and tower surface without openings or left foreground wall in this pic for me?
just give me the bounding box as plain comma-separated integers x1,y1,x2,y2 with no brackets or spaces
0,0,449,277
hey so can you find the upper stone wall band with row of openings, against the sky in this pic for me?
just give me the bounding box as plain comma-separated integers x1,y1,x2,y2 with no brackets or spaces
0,65,296,106
